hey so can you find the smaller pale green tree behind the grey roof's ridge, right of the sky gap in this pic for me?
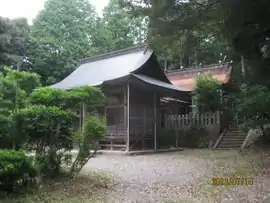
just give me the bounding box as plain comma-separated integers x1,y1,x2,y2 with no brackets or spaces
93,0,147,53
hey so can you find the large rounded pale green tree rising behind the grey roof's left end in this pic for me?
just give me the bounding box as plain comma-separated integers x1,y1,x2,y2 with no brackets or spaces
28,0,97,85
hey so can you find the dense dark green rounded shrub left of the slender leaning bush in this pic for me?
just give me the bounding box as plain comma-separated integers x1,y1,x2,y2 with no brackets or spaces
13,105,74,174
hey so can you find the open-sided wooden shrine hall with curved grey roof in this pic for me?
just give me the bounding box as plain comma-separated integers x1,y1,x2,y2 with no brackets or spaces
52,46,191,151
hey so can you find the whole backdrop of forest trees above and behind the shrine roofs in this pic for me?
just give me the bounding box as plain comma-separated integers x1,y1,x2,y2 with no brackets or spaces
0,0,270,85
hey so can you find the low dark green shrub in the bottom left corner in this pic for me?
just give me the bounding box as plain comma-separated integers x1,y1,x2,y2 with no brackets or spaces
0,150,38,190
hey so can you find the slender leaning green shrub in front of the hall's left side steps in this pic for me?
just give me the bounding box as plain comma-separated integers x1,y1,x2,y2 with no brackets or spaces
70,115,106,175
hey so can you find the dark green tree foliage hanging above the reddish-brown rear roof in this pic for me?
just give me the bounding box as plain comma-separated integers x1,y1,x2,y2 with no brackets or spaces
122,0,232,67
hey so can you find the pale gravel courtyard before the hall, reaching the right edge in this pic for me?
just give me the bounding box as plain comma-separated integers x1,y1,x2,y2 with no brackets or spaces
85,150,270,203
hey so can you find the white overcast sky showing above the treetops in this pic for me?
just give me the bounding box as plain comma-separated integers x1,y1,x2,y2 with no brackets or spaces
0,0,109,23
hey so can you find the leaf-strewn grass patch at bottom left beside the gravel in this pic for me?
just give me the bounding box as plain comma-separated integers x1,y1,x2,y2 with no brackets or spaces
0,171,115,203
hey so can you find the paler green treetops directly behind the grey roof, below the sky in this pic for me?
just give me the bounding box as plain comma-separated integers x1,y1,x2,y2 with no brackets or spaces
24,0,146,85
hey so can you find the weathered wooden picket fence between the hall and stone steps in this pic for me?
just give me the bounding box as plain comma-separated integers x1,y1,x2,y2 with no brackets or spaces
166,111,220,128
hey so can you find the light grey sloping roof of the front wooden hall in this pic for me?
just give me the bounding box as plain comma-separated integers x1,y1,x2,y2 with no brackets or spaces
52,45,190,91
